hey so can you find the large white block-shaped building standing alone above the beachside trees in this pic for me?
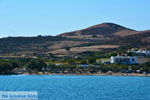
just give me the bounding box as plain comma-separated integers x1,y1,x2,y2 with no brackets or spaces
110,56,138,64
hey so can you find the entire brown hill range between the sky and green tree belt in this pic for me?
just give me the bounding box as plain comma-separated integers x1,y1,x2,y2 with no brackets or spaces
0,23,150,55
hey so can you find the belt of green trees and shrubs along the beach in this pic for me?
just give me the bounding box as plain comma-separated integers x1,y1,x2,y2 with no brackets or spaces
0,58,150,74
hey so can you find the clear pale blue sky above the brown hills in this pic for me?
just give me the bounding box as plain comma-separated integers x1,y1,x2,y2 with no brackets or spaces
0,0,150,37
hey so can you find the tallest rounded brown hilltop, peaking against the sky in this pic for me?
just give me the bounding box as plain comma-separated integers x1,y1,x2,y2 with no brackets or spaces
59,23,137,39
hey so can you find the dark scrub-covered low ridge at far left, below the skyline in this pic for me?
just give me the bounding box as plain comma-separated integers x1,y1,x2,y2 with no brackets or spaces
0,35,70,53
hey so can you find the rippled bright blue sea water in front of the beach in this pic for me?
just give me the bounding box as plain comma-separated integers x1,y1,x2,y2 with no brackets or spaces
0,75,150,100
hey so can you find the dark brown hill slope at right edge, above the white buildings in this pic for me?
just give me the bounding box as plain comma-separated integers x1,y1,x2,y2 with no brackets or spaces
106,31,150,49
